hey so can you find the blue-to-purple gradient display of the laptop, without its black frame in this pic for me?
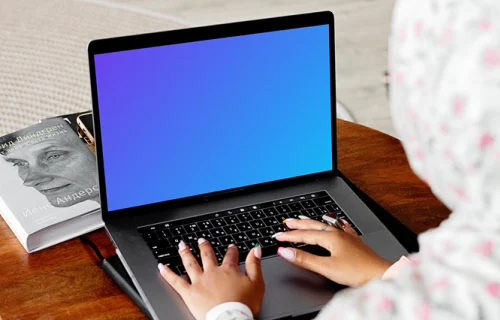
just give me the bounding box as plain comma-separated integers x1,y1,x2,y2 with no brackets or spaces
94,25,332,211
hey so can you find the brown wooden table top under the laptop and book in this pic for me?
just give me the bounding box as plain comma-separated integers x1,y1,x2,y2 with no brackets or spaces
0,120,449,320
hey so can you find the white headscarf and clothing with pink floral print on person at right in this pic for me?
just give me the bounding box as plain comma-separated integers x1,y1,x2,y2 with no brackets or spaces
318,0,500,320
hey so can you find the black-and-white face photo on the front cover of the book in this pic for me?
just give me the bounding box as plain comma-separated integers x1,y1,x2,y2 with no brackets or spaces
0,119,99,207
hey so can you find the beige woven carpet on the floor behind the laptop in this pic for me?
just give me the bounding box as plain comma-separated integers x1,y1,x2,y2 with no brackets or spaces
0,0,352,135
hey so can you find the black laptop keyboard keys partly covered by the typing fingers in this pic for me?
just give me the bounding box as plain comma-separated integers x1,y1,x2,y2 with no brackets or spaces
138,191,361,274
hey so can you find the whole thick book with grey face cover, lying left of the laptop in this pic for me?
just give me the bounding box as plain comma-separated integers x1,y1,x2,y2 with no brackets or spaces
0,117,104,253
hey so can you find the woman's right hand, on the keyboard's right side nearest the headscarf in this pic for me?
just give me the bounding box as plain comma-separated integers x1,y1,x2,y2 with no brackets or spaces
274,219,392,286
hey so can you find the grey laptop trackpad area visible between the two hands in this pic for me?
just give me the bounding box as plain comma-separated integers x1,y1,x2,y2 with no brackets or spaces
250,257,344,320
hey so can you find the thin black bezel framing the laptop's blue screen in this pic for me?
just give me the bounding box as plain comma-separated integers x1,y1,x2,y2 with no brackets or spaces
88,11,337,221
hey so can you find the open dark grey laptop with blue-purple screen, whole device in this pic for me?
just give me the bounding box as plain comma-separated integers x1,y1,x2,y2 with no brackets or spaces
88,12,407,319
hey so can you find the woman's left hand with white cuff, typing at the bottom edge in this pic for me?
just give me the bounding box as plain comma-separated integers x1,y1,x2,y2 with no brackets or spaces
158,238,265,320
